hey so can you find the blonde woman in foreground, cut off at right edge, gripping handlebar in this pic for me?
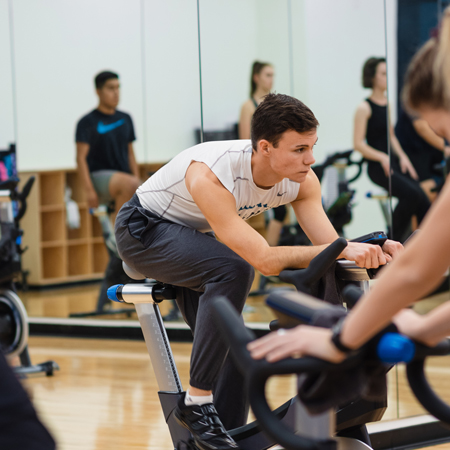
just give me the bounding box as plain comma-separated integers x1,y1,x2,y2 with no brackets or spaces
248,7,450,362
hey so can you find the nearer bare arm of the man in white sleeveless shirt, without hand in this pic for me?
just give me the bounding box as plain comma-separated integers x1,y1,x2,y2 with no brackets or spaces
185,162,328,275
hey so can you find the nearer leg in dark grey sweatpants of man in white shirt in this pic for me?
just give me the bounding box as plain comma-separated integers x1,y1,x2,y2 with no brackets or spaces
116,204,254,432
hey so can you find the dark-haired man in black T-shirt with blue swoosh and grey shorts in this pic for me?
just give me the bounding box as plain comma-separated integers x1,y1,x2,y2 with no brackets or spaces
76,72,140,221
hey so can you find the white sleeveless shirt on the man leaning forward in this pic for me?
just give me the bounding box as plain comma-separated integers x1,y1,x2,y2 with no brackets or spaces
136,140,300,232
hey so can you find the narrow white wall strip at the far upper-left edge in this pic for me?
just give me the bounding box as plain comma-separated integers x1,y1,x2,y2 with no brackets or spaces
0,0,15,149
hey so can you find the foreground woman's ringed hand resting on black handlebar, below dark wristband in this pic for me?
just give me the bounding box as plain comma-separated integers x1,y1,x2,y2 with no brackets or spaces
247,325,345,363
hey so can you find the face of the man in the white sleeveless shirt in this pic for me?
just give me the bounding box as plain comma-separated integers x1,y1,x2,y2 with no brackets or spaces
262,130,317,183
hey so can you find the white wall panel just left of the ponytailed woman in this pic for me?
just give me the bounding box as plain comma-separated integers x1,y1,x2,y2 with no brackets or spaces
200,0,257,130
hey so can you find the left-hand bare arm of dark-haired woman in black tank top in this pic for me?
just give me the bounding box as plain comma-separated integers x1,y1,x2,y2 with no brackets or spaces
353,102,390,176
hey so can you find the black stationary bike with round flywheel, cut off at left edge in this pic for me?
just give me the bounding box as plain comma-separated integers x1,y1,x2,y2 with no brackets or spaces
0,177,59,375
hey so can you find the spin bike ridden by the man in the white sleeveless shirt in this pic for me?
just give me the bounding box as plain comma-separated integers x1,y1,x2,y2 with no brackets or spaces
108,238,387,450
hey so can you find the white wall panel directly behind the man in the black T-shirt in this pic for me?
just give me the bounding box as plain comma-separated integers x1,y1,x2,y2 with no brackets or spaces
13,0,143,170
